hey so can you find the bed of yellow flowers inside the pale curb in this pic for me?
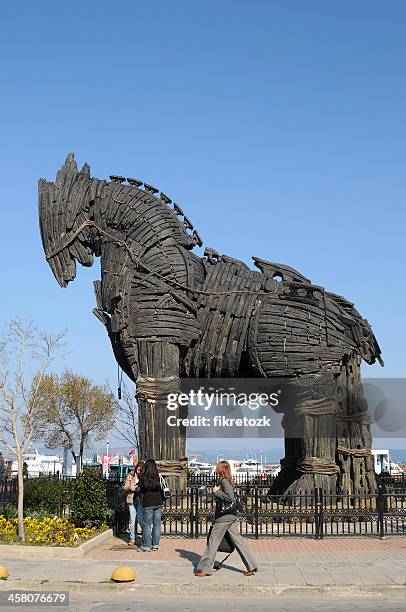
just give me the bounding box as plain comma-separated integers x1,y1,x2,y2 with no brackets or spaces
0,515,107,546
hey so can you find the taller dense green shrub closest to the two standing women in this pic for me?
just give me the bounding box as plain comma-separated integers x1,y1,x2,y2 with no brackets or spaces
69,468,112,527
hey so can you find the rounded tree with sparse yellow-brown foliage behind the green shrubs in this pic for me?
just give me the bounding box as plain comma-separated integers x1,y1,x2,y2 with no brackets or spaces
35,372,116,463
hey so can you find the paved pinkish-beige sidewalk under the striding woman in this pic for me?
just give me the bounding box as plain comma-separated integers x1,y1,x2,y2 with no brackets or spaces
0,538,406,595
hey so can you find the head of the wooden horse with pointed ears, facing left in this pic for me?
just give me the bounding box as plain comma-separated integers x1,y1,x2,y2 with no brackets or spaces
38,153,104,287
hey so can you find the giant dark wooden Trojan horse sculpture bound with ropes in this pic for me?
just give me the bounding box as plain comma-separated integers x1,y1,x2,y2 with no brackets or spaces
39,154,383,493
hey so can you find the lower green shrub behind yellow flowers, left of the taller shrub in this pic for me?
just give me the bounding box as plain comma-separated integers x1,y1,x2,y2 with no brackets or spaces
24,474,69,516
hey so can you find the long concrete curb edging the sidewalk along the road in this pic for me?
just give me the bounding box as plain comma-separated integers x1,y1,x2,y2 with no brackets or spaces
0,579,406,598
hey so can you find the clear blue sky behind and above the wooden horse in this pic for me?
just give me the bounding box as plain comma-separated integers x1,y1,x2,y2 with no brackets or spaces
0,0,406,454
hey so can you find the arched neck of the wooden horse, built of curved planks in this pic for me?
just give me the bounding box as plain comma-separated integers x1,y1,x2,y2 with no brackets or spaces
94,180,204,310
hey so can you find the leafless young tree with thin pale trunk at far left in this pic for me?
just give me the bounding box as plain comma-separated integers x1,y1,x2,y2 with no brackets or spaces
0,319,66,541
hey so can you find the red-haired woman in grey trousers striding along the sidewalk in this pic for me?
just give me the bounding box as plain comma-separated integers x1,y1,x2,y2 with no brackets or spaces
195,461,257,577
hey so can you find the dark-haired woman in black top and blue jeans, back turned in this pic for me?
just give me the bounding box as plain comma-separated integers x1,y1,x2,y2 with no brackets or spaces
140,459,163,552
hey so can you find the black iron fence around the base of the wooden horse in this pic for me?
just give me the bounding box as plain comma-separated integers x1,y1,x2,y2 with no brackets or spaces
0,475,406,539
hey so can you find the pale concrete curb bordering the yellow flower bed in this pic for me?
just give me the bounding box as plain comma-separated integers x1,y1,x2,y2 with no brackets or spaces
0,529,113,561
